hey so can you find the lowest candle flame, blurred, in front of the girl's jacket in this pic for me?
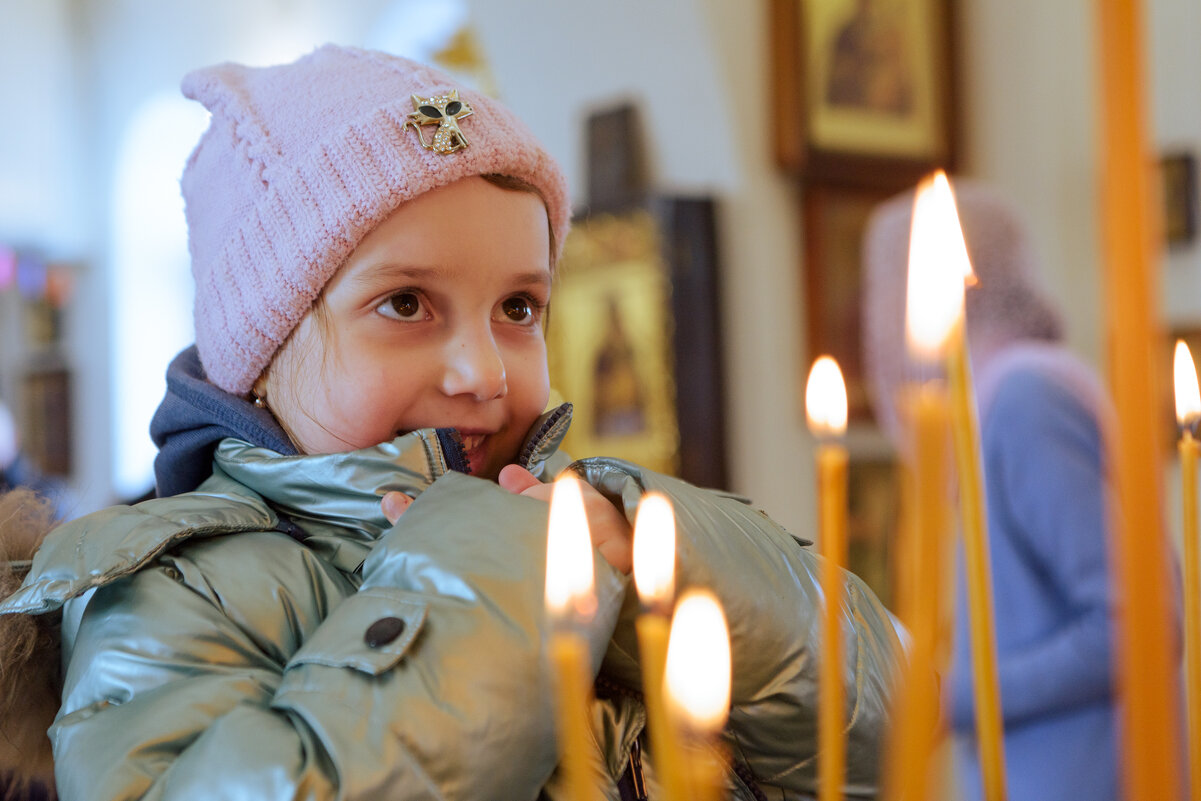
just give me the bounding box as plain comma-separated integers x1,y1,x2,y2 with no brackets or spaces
663,590,730,733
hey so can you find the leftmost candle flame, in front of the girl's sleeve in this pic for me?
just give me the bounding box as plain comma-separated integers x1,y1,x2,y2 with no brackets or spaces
546,476,596,616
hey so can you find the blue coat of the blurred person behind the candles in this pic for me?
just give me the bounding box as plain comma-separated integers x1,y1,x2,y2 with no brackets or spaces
950,342,1181,801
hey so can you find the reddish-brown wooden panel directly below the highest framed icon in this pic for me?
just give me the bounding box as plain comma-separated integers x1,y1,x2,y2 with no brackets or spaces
799,186,891,424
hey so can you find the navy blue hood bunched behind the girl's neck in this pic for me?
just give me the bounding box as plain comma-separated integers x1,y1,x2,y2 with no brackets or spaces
150,345,297,497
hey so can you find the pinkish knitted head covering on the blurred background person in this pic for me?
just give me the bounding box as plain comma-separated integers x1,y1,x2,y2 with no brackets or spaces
861,179,1063,450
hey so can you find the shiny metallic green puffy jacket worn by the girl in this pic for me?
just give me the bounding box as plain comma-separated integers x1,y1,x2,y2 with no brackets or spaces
0,410,898,801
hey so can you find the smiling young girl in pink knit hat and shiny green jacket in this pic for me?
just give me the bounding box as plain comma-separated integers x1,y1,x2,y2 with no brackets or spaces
0,46,897,799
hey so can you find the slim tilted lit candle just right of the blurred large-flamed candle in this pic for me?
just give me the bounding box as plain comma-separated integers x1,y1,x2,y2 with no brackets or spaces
925,171,1008,801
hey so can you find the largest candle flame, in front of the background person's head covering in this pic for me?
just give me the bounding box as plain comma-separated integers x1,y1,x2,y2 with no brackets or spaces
906,171,974,361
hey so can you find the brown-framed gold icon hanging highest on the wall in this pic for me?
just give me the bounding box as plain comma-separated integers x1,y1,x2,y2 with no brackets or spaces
772,0,955,189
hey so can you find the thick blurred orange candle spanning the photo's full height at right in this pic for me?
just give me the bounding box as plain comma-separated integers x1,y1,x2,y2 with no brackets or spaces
1098,0,1179,800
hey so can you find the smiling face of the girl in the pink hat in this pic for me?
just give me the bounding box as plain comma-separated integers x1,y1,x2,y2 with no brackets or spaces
265,178,550,479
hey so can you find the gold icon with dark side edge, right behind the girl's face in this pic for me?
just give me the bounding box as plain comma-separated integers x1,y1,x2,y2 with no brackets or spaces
546,199,725,486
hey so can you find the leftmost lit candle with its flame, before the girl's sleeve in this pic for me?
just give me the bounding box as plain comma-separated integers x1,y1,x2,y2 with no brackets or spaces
546,476,601,801
